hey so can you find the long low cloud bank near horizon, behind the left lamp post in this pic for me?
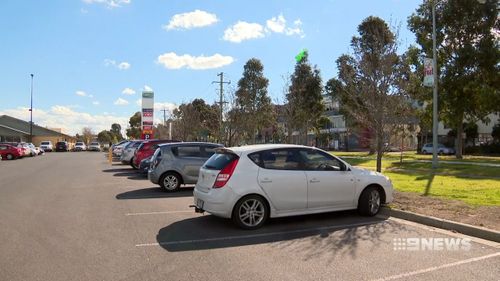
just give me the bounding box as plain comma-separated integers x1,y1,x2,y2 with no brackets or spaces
0,105,132,135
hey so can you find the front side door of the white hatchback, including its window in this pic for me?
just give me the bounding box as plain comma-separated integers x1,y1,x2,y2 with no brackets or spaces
300,149,356,209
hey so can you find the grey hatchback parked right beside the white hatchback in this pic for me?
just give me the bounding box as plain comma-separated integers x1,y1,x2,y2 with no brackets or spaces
148,142,222,191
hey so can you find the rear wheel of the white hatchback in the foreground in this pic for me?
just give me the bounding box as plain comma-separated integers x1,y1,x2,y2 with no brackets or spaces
231,195,269,229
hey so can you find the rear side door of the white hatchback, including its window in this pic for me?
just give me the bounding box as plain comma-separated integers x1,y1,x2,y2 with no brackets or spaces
256,149,307,212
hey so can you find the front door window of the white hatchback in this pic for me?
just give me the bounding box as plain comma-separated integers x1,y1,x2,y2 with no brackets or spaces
300,149,344,171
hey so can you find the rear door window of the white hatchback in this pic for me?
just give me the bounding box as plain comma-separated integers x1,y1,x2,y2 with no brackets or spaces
258,149,303,170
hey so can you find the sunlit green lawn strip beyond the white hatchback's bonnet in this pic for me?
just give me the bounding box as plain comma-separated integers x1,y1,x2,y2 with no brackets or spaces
333,152,500,206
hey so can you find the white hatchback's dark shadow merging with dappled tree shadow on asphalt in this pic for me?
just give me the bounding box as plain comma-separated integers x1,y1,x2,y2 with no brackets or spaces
156,211,414,256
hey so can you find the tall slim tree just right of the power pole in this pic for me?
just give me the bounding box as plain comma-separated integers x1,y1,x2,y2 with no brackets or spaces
233,58,274,144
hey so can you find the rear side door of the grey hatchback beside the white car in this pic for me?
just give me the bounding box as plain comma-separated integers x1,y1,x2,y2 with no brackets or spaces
172,145,207,184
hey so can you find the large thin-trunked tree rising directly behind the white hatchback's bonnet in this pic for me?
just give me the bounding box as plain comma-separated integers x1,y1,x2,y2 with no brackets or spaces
329,17,409,172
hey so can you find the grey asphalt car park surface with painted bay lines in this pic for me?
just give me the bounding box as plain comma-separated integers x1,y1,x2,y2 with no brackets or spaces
0,153,500,280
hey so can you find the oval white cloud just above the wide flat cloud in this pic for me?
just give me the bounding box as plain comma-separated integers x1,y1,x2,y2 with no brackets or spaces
163,10,219,30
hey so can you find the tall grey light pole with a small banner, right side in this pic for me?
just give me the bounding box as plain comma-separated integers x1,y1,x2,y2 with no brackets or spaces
432,0,438,169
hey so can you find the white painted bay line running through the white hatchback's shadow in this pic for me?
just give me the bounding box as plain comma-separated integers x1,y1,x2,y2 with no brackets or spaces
135,221,386,247
